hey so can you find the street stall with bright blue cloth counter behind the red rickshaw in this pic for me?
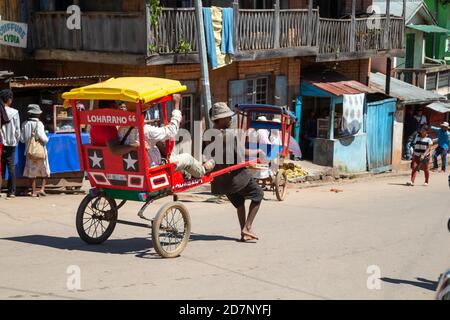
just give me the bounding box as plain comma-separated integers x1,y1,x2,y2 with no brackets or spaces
3,76,107,190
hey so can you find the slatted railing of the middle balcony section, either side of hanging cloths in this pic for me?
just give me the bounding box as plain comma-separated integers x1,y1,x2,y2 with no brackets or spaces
148,8,319,54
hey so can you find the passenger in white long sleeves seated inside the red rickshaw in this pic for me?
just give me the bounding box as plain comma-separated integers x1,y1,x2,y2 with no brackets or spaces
119,94,215,178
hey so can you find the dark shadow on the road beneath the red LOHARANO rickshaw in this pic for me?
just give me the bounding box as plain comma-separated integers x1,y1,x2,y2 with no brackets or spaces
0,233,237,259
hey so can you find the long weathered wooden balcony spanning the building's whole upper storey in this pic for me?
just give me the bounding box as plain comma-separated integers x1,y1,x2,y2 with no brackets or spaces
31,7,404,65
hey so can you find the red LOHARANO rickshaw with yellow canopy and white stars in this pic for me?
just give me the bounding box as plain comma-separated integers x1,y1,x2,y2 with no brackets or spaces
63,78,256,258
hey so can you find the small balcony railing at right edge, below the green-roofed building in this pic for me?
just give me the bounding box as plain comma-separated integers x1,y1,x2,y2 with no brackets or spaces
394,65,450,91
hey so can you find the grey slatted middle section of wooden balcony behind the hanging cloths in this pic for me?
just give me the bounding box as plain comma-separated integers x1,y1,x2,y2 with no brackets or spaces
148,8,319,64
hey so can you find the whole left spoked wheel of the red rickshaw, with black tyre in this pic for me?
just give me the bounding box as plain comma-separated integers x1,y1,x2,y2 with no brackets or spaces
76,195,118,244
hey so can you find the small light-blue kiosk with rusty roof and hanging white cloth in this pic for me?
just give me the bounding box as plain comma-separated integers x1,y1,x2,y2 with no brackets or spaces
301,73,395,173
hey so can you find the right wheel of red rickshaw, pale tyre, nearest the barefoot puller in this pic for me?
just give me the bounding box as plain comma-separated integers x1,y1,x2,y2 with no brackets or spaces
152,202,191,258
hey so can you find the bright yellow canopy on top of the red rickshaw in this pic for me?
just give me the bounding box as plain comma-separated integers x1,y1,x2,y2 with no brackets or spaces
62,77,187,103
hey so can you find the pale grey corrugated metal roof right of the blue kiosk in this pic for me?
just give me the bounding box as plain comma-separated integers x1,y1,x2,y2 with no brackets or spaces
369,73,447,105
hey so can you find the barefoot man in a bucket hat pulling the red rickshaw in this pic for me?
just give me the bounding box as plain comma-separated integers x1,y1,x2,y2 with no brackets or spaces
210,102,264,241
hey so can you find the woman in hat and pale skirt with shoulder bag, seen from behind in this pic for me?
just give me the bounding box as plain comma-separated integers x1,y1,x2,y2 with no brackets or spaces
20,104,50,197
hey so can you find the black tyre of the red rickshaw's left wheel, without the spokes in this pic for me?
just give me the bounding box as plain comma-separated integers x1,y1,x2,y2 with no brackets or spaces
76,194,118,244
